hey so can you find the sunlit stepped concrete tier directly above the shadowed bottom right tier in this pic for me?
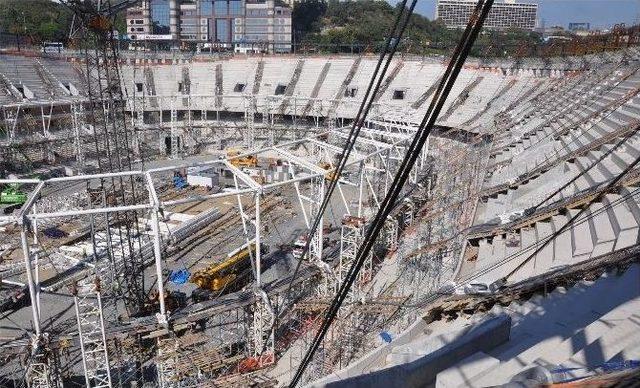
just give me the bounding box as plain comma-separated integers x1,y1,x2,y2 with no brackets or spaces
467,183,640,283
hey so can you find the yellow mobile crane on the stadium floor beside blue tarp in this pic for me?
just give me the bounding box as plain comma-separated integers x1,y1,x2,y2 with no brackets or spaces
189,243,267,302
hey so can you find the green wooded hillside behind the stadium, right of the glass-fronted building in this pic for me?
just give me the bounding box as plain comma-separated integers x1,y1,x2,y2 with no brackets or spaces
293,0,541,56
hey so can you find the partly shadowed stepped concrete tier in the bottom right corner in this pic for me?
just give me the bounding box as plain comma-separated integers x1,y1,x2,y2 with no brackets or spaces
436,264,640,388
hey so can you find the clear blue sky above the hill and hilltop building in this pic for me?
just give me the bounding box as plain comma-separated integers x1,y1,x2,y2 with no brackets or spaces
388,0,640,28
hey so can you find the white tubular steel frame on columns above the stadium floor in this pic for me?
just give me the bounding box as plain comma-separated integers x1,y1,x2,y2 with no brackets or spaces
0,122,422,386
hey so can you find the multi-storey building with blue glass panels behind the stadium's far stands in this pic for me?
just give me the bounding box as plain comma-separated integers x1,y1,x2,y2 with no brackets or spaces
127,0,292,52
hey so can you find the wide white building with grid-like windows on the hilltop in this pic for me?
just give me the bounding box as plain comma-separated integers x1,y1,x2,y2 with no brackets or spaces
435,0,538,30
